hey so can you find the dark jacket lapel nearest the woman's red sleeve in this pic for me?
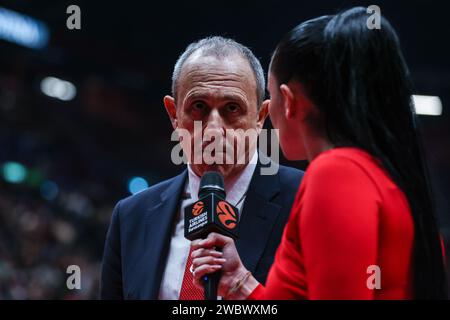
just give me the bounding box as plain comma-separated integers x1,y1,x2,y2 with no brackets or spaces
236,154,281,273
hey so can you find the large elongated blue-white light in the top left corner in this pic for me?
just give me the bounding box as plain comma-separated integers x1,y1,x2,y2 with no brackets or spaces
0,7,50,49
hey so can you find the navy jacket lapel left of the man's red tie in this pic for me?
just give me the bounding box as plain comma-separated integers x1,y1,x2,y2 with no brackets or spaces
132,170,187,300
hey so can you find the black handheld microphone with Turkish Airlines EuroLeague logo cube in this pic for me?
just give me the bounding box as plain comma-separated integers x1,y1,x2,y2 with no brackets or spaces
184,171,238,300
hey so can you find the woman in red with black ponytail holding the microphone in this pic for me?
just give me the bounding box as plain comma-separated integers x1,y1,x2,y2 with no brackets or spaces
192,7,447,299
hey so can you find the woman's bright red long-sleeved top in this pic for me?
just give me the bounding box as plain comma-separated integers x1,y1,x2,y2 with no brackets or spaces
248,148,414,300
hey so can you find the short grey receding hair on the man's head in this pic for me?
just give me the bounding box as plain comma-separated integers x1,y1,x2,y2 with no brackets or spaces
172,37,265,108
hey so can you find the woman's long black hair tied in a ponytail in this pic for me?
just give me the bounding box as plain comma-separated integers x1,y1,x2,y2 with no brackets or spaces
270,7,447,299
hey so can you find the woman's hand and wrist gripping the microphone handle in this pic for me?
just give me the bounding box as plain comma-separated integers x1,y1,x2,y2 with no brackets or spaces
191,232,258,299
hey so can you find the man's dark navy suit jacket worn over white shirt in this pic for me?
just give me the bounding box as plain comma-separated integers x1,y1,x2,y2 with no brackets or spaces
100,163,303,299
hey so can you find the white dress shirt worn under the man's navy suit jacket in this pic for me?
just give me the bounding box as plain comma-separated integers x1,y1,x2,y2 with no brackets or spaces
158,151,258,300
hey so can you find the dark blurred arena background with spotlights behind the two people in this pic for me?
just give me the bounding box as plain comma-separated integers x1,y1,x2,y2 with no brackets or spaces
0,0,450,299
